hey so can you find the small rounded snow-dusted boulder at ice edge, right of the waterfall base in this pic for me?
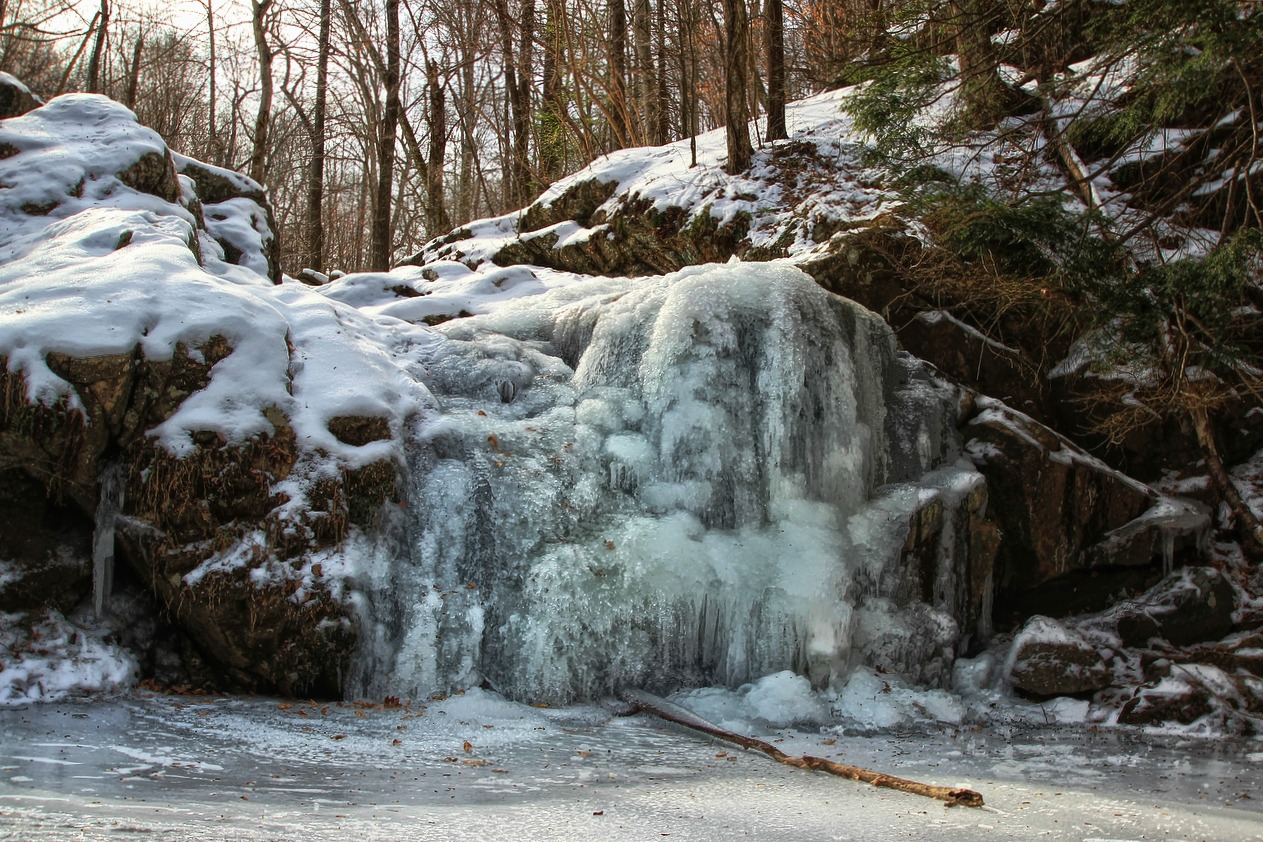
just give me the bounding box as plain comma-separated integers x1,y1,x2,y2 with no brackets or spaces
1008,616,1114,697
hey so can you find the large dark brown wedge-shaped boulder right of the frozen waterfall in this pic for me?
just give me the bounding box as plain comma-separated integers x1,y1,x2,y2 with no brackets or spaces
964,398,1210,624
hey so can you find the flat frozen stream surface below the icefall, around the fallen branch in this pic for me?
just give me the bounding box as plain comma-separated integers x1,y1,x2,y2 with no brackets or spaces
0,691,1263,842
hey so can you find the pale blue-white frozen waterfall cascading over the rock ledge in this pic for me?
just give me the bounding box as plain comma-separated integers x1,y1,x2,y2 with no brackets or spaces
353,264,980,702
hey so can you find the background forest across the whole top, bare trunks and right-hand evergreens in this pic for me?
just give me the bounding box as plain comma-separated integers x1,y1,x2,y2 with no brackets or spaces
7,0,1263,275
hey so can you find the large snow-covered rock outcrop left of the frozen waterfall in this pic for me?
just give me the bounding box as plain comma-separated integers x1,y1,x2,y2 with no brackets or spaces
0,87,402,696
